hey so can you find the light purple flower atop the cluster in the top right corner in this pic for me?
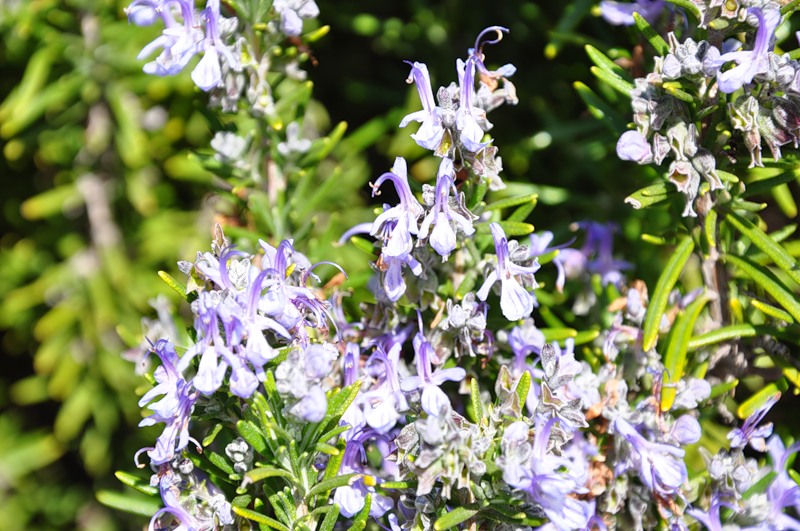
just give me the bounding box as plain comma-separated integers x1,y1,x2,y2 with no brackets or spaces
714,7,781,94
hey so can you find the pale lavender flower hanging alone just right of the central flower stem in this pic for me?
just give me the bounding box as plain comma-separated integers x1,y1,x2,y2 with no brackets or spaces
477,223,539,321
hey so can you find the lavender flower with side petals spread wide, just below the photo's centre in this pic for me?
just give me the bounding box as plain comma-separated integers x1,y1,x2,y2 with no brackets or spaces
400,324,467,417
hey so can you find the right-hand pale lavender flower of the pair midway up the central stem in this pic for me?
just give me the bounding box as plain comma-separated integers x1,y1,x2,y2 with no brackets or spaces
418,157,475,260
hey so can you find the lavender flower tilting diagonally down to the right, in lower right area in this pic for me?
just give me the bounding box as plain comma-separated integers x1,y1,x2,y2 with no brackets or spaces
612,416,688,497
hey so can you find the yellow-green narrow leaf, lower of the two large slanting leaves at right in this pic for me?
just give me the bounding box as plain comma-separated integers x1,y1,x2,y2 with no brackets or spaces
661,292,712,411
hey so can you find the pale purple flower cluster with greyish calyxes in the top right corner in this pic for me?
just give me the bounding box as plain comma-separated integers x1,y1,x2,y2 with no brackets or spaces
617,2,800,216
